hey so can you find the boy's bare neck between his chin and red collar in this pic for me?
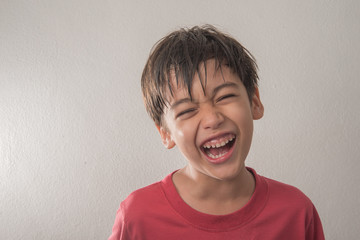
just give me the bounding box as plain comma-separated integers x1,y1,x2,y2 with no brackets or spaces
173,166,255,214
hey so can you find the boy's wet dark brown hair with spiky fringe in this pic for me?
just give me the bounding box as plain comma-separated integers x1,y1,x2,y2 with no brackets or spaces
141,25,258,126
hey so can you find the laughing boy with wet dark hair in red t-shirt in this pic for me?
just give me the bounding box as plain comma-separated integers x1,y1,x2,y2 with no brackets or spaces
109,26,324,240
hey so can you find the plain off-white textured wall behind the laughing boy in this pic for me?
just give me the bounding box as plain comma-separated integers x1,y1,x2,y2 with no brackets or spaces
0,0,360,240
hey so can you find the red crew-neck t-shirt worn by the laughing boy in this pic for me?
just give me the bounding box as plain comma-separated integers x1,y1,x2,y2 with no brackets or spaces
109,168,324,240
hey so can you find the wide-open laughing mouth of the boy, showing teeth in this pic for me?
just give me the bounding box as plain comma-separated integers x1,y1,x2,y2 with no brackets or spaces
202,134,235,160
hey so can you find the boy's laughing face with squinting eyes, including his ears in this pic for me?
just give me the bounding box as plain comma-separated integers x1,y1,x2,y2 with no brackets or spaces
158,59,263,180
